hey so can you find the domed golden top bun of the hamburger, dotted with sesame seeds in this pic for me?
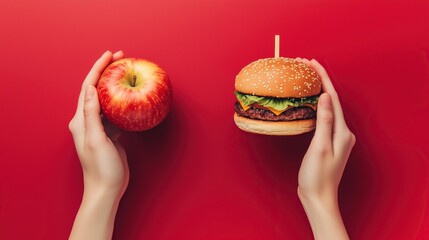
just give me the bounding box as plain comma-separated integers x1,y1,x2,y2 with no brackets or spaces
235,57,322,98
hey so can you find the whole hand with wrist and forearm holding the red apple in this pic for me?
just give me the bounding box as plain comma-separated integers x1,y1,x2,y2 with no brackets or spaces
69,51,129,240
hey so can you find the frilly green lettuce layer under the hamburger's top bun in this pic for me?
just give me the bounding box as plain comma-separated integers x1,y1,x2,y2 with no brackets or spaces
234,91,319,111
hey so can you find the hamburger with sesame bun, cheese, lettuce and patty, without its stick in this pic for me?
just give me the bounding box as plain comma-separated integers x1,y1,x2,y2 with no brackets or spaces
234,57,322,135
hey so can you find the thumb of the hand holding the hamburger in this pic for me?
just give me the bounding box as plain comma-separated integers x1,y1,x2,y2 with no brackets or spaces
310,93,335,151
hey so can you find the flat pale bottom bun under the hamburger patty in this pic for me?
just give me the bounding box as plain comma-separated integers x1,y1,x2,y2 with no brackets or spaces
234,113,316,136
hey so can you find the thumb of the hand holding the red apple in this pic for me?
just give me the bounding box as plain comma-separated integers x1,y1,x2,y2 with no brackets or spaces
83,85,104,139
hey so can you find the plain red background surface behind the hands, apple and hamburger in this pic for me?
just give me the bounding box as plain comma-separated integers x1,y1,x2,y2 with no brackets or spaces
0,0,429,239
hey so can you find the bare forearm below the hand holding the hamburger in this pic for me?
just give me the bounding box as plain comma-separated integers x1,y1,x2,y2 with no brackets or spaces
300,193,349,240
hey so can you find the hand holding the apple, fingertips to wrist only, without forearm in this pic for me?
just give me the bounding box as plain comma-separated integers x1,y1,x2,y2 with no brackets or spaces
69,51,129,195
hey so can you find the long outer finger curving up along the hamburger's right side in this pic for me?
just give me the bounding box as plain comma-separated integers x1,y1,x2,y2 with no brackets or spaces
310,59,347,132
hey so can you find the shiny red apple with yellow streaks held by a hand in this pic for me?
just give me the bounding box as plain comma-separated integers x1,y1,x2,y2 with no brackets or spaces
97,58,172,131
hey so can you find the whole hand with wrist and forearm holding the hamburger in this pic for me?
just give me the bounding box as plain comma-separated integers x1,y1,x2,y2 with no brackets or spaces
297,59,356,239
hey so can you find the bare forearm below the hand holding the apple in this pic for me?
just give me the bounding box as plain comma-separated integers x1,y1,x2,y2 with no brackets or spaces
69,189,121,240
